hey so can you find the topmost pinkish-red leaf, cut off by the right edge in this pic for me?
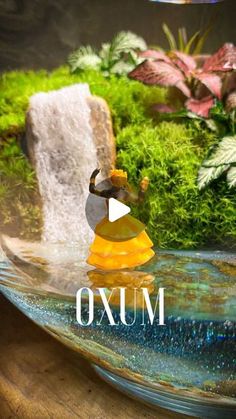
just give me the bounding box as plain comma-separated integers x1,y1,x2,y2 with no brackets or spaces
203,43,236,72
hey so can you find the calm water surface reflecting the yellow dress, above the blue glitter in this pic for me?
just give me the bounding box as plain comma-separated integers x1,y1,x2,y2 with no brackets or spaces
2,237,236,320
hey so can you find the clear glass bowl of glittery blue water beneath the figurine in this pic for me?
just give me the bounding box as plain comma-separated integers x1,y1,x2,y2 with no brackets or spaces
0,236,236,418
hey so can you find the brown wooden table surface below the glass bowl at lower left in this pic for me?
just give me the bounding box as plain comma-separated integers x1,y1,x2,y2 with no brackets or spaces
0,295,190,419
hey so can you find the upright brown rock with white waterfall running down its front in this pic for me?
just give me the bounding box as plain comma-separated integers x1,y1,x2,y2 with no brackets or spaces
26,84,115,244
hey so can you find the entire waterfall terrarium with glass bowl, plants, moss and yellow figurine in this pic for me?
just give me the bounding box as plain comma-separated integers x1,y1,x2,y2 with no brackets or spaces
0,13,236,417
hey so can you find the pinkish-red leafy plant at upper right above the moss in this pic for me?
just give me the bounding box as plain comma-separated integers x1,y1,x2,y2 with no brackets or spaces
129,43,236,118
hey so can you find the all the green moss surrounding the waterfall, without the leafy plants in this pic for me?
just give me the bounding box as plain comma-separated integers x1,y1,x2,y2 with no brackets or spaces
0,67,236,248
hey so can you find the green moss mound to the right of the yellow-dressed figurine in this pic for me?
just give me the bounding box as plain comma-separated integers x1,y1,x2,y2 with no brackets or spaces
117,122,236,248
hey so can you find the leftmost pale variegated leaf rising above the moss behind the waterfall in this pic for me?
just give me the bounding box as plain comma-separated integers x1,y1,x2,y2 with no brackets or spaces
68,45,101,73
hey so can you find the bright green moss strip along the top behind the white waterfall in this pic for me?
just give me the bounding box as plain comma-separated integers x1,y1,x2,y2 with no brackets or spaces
0,67,166,135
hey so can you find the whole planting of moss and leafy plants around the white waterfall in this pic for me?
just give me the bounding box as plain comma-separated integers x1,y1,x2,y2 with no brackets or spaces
0,24,236,248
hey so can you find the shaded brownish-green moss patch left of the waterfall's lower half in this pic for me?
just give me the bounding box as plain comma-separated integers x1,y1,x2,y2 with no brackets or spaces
0,136,42,237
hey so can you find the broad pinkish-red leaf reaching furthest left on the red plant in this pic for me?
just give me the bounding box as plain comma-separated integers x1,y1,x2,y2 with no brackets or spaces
129,60,191,97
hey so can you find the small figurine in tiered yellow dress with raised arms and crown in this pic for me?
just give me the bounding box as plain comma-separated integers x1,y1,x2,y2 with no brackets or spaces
87,169,155,270
